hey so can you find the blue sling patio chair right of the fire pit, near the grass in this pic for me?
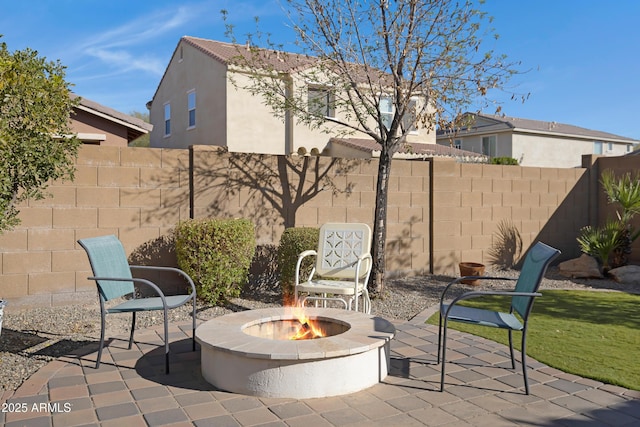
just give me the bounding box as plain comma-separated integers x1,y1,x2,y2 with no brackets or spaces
438,242,560,394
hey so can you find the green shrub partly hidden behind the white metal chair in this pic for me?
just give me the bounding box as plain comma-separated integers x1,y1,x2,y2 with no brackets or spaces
277,227,320,298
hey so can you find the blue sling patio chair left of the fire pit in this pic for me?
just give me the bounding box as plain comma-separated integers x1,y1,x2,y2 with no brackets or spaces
78,235,196,374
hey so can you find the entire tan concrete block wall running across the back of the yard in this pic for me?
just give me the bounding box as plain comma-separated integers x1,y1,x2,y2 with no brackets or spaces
0,146,616,306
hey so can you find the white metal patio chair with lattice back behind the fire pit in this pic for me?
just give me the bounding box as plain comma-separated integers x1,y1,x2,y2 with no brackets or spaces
294,223,372,313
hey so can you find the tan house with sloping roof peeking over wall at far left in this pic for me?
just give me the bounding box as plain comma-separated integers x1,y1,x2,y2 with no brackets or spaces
71,94,152,147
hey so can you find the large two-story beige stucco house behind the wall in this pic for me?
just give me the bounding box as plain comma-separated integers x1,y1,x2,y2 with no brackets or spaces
147,37,435,155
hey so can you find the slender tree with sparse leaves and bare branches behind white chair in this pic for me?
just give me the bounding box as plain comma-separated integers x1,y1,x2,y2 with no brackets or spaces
223,0,518,292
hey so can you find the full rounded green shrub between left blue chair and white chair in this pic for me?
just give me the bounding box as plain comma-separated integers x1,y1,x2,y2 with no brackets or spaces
175,219,256,304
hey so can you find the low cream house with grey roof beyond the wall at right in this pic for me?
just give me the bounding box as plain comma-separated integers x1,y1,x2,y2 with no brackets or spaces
436,113,640,168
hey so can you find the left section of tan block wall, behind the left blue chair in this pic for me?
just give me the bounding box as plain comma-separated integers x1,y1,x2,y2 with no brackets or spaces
0,146,189,305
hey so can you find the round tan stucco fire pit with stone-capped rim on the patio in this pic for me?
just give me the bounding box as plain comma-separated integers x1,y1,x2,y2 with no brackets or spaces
196,307,395,399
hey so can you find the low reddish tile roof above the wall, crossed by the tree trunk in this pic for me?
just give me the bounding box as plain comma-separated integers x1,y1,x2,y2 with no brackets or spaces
329,138,486,160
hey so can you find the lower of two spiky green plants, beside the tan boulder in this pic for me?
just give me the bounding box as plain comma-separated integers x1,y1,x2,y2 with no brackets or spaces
577,219,625,274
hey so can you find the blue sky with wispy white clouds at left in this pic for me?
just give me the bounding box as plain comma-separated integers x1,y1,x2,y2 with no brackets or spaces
0,0,640,140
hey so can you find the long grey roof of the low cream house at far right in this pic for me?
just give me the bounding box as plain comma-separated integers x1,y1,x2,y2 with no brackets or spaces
438,113,640,144
